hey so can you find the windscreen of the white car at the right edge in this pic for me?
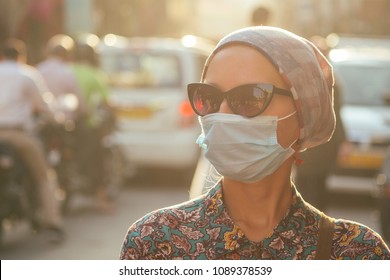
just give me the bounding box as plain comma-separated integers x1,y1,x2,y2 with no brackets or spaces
335,63,390,106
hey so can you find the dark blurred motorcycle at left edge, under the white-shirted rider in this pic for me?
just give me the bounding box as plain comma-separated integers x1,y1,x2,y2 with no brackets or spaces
0,141,39,243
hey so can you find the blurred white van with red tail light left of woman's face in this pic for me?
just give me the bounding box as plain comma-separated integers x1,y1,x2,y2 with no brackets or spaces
99,34,214,175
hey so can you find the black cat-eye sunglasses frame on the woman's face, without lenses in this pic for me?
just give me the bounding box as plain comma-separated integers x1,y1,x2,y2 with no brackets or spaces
187,83,292,118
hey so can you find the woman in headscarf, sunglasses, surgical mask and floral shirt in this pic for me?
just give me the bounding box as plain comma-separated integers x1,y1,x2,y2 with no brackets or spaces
120,27,390,259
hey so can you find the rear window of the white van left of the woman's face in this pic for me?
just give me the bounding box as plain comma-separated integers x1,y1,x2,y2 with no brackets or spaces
101,52,181,87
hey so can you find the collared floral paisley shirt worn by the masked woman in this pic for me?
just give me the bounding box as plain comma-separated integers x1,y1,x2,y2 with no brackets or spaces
120,182,390,260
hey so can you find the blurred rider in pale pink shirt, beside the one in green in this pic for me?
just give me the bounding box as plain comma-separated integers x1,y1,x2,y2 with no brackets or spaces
36,34,87,122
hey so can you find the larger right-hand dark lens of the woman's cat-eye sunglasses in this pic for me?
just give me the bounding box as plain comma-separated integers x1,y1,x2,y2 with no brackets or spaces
228,86,270,117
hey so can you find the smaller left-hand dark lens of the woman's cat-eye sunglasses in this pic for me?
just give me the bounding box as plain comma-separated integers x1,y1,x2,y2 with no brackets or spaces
190,85,221,116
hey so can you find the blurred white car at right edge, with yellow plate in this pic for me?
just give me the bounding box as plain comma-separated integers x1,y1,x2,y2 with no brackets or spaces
328,38,390,194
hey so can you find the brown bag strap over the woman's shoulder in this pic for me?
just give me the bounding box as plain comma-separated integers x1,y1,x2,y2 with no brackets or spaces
315,213,334,260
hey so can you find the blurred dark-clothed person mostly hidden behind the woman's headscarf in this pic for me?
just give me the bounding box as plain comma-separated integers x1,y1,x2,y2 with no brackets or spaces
295,36,346,211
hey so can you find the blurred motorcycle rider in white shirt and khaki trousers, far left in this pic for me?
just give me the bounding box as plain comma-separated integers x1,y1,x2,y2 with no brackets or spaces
0,38,65,242
